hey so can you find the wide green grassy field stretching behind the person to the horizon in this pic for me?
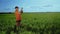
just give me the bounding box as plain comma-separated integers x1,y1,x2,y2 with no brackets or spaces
0,12,60,34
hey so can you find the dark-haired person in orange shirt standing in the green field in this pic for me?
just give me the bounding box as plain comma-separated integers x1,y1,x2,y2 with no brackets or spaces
14,6,23,34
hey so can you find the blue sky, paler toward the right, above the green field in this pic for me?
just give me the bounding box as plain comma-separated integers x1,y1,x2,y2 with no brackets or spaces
0,0,60,12
